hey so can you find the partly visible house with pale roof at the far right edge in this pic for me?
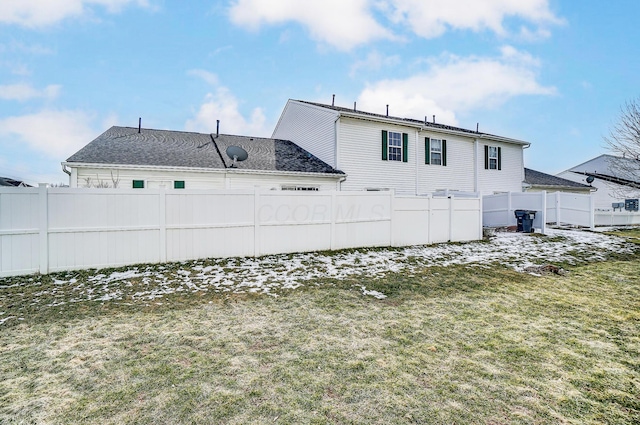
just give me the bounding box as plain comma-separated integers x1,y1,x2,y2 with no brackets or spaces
558,154,640,210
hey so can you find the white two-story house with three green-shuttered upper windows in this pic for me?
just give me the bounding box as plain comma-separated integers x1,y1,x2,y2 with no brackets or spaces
272,100,530,195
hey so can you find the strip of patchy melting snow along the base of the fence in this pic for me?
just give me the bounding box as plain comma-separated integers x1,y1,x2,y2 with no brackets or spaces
0,229,634,325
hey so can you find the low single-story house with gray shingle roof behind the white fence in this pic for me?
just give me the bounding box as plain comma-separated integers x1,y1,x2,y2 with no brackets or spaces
62,127,345,190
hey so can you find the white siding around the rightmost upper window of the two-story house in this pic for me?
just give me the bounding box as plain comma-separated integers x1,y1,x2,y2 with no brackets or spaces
476,140,524,195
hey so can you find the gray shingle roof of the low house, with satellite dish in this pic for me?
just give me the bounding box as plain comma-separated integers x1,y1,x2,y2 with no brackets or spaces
67,126,343,174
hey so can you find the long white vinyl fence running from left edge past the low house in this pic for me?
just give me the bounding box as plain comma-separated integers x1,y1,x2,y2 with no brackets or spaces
0,185,482,276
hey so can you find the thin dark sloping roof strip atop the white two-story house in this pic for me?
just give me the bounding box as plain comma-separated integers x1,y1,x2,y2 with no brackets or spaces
293,100,530,145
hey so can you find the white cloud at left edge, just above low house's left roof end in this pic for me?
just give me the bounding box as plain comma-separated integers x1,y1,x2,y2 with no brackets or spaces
0,110,96,161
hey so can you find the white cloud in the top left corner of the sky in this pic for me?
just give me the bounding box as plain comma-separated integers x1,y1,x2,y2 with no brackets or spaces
0,0,149,28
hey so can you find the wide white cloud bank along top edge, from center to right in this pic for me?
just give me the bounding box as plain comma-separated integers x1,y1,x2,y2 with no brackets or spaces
229,0,563,50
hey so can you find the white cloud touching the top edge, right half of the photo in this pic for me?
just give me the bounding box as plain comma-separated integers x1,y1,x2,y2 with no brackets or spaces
388,0,562,38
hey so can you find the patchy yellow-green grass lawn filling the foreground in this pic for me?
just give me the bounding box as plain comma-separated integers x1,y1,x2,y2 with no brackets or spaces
0,230,640,424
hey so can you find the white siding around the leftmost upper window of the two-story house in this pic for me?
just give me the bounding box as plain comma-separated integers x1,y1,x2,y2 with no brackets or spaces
337,117,416,195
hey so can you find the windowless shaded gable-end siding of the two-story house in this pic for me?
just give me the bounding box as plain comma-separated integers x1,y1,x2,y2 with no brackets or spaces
272,100,338,168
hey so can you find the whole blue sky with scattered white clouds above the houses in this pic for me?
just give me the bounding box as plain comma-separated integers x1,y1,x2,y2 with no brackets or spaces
0,0,640,184
